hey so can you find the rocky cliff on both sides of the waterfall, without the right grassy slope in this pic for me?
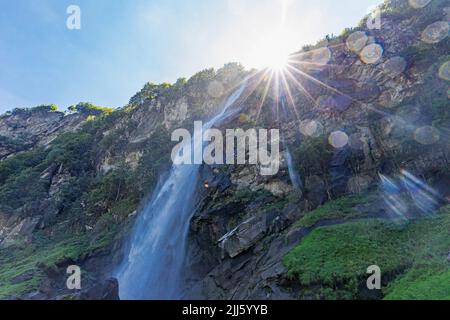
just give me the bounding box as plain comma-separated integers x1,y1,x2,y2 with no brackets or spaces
0,0,450,300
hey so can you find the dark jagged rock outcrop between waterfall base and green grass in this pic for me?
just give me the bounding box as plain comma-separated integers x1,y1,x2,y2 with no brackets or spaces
185,200,306,300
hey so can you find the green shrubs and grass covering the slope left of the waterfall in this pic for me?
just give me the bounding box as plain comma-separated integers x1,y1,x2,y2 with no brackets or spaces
0,103,176,299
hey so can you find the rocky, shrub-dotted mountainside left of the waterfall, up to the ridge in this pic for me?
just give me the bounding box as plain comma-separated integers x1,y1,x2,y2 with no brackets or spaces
0,64,247,300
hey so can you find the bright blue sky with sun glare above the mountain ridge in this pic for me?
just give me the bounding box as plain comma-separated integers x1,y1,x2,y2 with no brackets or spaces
0,0,382,113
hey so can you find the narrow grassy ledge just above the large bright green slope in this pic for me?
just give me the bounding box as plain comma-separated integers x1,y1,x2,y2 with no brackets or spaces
296,195,367,228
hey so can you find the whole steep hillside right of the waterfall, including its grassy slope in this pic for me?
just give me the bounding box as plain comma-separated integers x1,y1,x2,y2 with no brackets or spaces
186,1,450,299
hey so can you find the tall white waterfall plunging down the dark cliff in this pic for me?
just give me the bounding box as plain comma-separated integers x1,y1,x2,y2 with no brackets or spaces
116,81,247,300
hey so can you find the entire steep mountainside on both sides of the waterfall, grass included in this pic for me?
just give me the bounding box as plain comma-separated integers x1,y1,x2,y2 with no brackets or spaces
0,0,450,299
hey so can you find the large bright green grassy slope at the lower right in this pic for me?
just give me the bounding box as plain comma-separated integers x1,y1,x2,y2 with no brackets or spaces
283,206,450,299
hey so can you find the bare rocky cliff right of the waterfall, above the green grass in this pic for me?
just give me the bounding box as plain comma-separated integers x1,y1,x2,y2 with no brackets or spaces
181,1,450,299
